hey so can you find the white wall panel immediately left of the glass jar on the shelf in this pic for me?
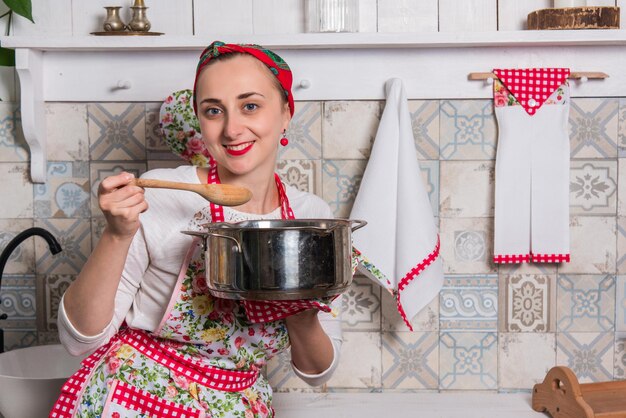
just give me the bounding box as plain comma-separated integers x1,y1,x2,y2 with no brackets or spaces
252,0,305,33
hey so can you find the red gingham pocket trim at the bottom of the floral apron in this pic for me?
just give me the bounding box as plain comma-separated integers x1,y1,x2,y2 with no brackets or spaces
103,380,205,418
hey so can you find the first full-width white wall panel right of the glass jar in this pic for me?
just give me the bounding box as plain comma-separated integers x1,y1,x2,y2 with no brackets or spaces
378,0,438,32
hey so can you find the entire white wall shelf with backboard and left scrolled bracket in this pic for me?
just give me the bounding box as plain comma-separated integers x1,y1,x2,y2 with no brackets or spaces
0,30,626,183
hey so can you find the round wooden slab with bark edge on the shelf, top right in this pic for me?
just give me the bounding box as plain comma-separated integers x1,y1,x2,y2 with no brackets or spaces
527,7,620,30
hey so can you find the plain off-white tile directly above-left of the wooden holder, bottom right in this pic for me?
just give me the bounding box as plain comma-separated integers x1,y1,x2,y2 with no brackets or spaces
498,332,556,390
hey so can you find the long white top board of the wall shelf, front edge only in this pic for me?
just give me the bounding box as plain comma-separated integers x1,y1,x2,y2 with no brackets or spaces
0,29,626,51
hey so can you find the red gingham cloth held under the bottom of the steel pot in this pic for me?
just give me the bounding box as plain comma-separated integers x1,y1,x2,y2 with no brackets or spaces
241,299,332,324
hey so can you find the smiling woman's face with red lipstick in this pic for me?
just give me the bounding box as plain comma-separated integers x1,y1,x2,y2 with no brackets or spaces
196,55,290,175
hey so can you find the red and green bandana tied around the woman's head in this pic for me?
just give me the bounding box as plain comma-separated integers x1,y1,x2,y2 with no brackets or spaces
193,41,294,116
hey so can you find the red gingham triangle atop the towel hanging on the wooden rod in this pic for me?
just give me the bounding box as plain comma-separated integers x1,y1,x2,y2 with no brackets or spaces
493,68,570,116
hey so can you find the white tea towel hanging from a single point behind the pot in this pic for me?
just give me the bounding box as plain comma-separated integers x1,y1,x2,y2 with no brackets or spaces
350,78,443,330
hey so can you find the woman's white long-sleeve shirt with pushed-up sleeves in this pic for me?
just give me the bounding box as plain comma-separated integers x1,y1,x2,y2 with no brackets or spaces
58,166,342,386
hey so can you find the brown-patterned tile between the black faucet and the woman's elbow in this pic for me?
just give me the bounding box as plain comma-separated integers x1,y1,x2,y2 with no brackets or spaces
37,275,76,331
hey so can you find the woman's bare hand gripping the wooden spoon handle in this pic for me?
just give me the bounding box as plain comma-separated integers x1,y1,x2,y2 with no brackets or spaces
98,172,148,239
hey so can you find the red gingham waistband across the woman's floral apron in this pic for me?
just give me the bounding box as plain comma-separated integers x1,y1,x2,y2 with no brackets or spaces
120,328,259,392
